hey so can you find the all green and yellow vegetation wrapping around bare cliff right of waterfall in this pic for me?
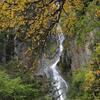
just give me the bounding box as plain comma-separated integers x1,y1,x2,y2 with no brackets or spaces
61,0,100,100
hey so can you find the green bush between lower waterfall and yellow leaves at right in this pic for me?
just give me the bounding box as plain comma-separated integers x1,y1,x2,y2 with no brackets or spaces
68,69,87,100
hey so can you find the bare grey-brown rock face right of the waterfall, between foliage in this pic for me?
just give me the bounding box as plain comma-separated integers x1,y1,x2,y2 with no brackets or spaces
60,29,99,72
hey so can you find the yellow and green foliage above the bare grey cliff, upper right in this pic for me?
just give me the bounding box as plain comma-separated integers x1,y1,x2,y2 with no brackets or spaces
61,0,100,45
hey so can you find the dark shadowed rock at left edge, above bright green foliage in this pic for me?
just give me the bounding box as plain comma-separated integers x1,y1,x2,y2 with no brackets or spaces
0,34,14,63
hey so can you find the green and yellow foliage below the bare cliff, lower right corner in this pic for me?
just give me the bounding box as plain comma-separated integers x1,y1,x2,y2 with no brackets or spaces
69,43,100,100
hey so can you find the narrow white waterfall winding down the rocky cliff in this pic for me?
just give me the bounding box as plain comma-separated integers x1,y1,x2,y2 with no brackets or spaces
45,24,68,100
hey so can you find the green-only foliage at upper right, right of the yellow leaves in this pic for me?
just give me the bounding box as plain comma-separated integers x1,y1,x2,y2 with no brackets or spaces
75,1,100,44
